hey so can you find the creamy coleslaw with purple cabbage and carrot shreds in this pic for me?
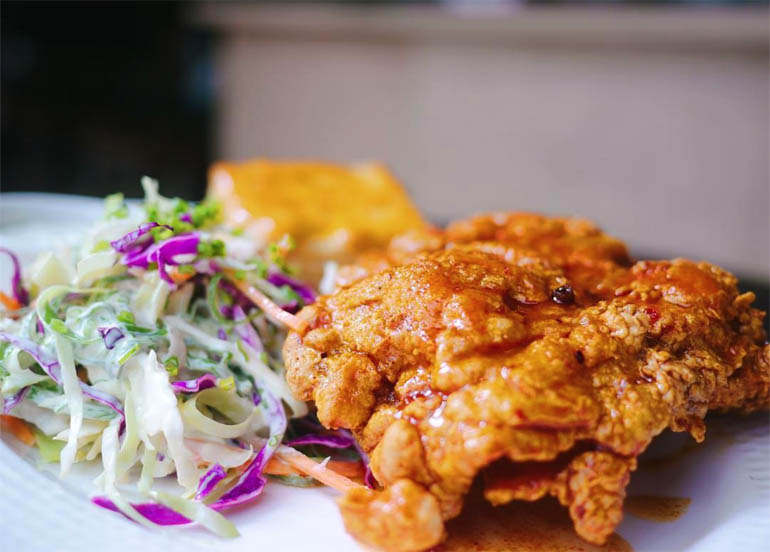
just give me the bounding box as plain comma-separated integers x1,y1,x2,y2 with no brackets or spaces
0,177,374,536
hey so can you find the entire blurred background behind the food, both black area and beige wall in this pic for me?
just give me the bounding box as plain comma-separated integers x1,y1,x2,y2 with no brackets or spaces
0,0,770,294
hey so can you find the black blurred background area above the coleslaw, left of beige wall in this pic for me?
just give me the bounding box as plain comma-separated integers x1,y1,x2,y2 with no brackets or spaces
0,2,213,198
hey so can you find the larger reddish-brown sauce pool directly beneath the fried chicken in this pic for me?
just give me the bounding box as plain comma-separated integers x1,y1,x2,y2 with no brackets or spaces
434,496,632,552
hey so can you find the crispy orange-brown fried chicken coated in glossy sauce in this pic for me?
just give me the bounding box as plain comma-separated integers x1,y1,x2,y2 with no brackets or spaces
284,214,770,551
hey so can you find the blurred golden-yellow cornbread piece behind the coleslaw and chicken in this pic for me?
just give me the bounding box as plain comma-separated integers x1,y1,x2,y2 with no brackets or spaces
208,159,426,281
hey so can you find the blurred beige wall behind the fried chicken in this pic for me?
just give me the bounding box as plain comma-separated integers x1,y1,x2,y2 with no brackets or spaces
195,6,770,279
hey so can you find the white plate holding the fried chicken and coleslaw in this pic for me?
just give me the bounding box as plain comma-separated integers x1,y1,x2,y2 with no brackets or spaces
0,194,770,552
